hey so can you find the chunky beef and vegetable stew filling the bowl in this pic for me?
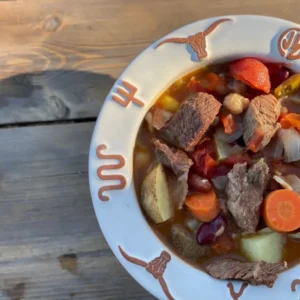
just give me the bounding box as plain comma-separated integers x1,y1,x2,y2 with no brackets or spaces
134,58,300,287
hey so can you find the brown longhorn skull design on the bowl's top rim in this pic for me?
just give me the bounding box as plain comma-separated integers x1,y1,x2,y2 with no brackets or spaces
156,19,232,59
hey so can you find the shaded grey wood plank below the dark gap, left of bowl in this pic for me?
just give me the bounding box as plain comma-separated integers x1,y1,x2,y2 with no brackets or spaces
0,123,153,300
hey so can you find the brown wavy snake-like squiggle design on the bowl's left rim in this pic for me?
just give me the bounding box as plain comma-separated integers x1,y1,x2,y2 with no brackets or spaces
96,145,126,201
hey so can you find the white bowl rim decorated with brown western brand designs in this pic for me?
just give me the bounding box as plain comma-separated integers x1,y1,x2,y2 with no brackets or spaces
89,16,300,300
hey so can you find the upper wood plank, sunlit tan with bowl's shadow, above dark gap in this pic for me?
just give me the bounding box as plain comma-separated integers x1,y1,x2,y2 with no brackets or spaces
0,0,299,124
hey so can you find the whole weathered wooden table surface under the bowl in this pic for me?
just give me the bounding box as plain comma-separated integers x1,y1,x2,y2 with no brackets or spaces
0,0,300,300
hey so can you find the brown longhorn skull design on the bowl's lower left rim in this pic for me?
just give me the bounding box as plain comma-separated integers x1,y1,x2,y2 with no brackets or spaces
119,246,175,300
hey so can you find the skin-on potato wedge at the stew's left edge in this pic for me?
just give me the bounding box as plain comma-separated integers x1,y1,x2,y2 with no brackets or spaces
141,164,173,223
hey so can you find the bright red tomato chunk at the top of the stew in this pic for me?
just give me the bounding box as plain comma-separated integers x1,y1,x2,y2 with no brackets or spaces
229,58,271,94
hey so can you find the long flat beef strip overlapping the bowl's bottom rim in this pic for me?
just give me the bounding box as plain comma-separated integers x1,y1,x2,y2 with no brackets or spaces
205,257,287,287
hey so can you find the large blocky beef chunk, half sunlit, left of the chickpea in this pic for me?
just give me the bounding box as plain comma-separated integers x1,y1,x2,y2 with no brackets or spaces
160,93,221,151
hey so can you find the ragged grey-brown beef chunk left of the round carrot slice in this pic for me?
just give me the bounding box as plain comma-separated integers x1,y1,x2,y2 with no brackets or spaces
226,159,270,233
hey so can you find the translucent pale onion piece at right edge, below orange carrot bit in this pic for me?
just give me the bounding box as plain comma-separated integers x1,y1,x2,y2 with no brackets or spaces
279,128,300,162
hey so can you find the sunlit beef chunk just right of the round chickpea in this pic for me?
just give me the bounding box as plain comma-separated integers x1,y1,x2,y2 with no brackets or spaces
243,95,281,151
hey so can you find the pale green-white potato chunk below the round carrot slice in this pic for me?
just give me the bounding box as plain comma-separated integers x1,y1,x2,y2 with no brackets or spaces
241,232,283,263
